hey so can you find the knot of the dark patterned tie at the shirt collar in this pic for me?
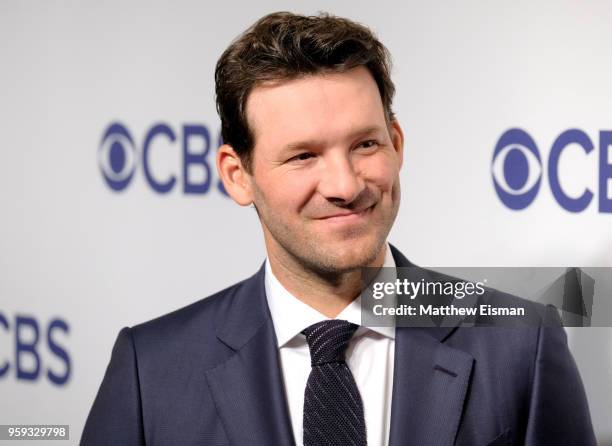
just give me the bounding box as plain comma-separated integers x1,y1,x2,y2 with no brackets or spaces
302,319,359,366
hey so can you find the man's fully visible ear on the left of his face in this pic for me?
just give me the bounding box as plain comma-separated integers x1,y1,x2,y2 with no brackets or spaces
217,144,253,206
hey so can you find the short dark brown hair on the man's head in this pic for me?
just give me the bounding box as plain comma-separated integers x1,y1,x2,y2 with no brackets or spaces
215,12,395,172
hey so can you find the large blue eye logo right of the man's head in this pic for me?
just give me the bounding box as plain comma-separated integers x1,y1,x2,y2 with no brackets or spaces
492,129,542,210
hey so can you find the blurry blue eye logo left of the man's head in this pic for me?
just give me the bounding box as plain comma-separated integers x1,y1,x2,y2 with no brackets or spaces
98,123,137,191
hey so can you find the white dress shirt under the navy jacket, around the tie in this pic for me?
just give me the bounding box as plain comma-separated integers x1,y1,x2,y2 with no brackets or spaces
265,245,395,446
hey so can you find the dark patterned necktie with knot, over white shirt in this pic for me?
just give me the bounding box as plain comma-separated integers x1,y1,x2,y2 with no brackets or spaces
302,320,367,446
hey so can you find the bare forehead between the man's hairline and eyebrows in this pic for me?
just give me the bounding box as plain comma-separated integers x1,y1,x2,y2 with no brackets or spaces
246,67,385,147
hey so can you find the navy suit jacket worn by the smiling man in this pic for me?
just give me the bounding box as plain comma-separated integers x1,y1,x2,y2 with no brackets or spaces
81,246,595,446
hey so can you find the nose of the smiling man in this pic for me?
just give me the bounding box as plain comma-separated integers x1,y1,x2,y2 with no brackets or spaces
319,154,365,204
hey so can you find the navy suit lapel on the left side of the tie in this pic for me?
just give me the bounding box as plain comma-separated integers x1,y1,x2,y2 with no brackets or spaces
206,266,294,446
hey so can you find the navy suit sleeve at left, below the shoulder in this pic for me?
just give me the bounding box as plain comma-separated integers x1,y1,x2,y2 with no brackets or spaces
80,327,145,446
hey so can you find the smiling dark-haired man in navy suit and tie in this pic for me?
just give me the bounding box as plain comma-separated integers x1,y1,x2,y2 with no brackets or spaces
82,13,595,446
